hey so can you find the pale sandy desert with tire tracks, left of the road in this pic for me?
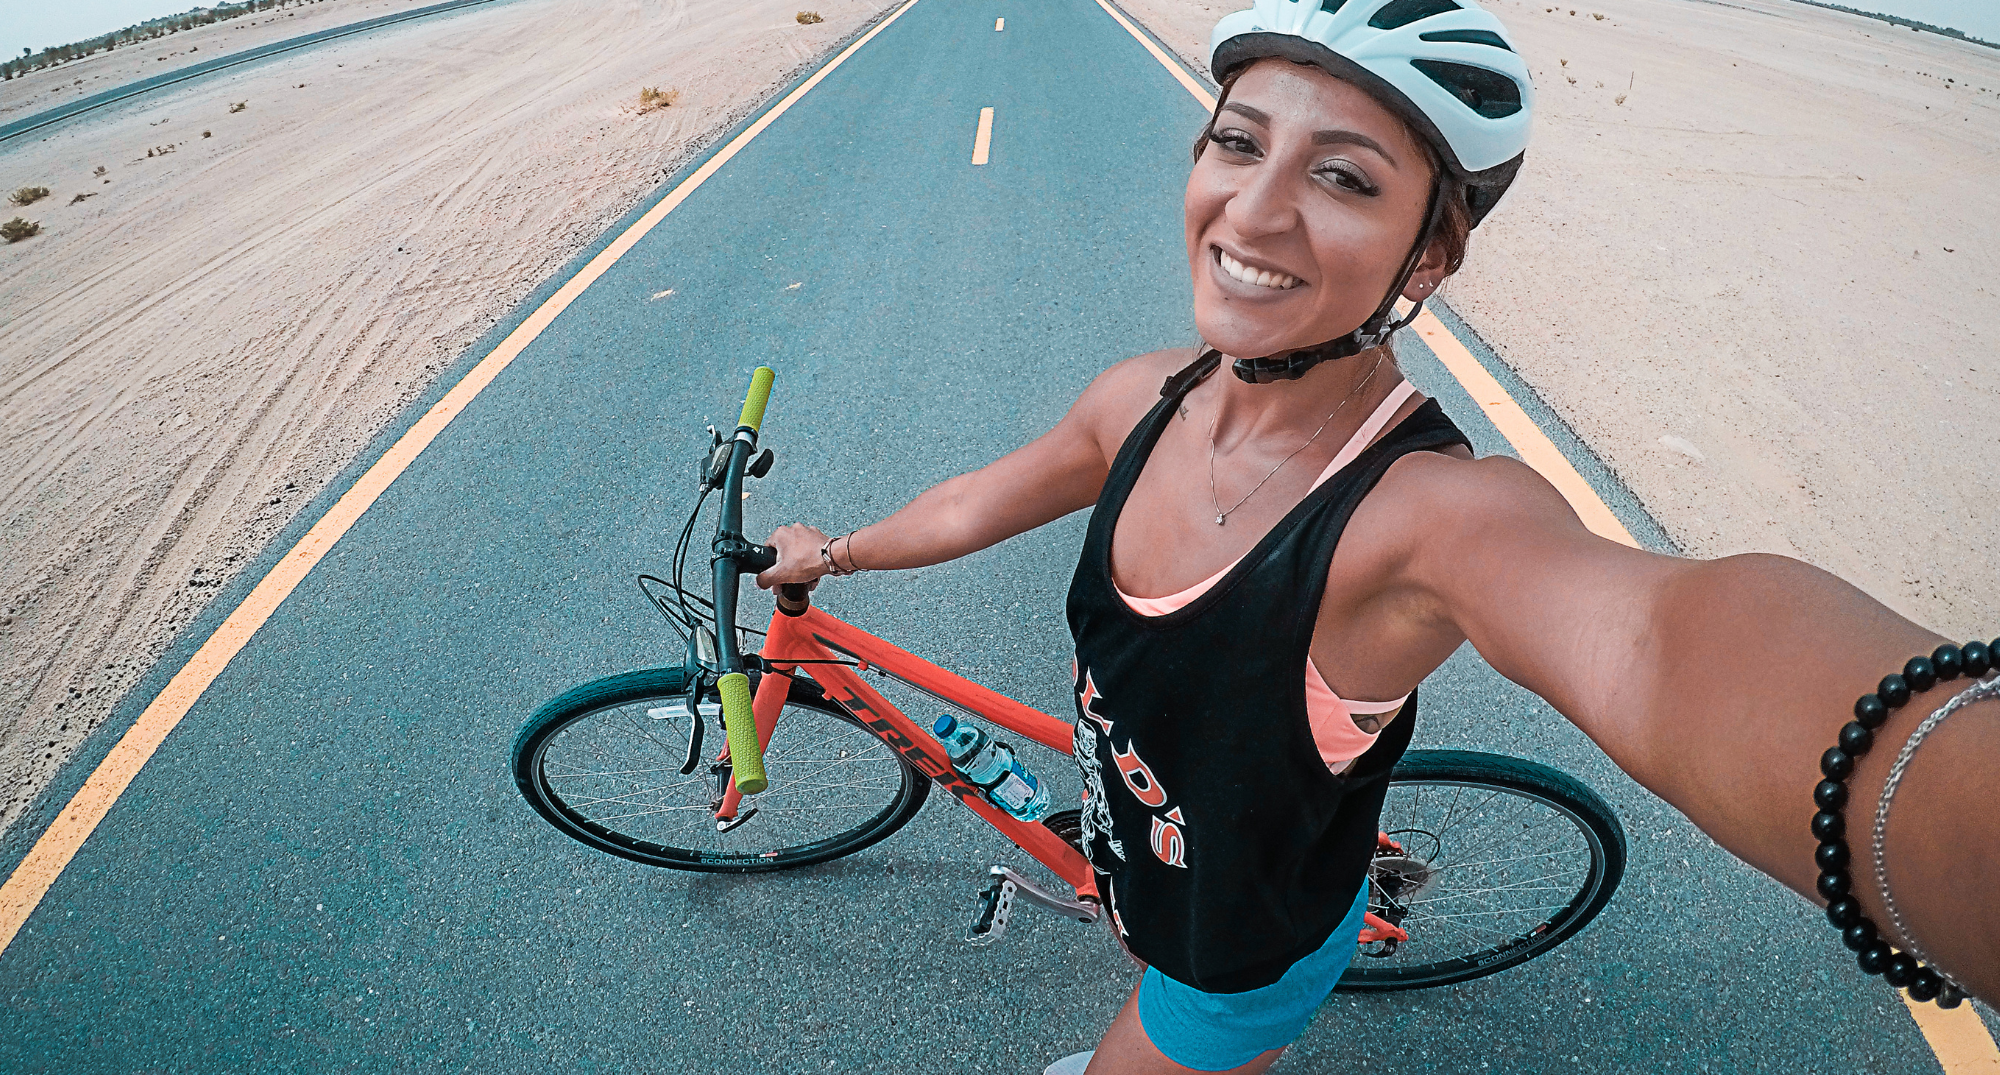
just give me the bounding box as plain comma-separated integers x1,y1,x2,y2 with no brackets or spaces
0,0,904,823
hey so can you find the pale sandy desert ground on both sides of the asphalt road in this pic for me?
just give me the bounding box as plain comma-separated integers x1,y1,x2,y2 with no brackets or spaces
0,0,2000,825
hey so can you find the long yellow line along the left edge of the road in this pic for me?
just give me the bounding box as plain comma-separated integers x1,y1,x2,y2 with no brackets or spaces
0,0,916,953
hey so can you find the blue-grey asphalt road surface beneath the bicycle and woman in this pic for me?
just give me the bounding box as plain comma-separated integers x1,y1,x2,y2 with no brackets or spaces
0,0,1938,1073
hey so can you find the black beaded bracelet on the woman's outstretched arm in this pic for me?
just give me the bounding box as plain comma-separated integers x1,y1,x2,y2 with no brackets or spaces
1812,637,2000,1007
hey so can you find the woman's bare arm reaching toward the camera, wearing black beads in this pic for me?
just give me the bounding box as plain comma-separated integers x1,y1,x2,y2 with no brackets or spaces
1392,456,2000,999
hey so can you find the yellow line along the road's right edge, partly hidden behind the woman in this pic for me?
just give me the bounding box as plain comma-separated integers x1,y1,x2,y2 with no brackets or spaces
1098,0,2000,1075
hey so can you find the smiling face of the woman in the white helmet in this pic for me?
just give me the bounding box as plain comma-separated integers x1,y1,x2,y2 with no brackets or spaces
1186,60,1442,358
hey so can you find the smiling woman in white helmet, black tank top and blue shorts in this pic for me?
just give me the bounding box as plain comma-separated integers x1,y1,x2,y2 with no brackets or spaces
758,0,2000,1075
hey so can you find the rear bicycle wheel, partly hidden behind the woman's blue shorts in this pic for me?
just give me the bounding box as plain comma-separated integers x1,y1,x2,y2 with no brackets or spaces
1336,749,1626,993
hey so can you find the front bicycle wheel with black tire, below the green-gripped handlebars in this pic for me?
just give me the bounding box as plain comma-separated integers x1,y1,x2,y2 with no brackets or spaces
514,667,930,873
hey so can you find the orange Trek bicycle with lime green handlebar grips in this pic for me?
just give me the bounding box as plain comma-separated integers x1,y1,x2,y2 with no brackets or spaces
512,366,1626,991
